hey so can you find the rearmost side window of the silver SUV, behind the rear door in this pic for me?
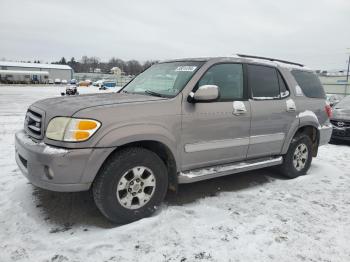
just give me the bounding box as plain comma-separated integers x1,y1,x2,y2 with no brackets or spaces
292,70,326,98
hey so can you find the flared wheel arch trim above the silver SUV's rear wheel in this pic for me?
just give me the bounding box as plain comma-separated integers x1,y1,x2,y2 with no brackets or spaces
281,110,320,155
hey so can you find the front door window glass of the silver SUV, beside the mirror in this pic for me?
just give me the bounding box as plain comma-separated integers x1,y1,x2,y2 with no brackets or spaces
198,64,243,101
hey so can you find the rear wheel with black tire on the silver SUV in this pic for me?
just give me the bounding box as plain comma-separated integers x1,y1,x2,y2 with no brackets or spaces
279,134,312,178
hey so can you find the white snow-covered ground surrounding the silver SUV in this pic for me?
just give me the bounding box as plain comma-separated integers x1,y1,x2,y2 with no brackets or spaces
0,86,350,262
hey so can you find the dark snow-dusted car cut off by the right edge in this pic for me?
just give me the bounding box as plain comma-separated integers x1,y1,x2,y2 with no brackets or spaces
331,96,350,141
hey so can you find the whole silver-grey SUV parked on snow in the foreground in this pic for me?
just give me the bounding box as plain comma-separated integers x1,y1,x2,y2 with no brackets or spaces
16,55,332,223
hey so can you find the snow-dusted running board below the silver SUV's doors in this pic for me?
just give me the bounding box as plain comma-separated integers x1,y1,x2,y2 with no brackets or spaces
178,156,283,184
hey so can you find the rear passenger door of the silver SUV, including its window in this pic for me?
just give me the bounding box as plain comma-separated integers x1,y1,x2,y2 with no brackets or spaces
247,64,296,158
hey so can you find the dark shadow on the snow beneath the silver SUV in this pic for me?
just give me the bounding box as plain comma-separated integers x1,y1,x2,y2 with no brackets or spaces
33,168,284,228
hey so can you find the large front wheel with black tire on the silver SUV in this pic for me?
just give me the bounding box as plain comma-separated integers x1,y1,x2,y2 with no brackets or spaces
92,147,168,224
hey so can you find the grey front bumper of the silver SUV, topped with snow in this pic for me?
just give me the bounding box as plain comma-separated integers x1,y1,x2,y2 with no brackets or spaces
15,130,113,192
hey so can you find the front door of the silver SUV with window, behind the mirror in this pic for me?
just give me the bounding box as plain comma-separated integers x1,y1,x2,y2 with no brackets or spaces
180,63,251,171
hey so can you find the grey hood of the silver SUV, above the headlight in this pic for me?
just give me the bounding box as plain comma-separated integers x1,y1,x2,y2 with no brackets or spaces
32,93,165,116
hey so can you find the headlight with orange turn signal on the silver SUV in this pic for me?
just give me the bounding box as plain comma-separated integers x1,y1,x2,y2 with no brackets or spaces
46,117,101,142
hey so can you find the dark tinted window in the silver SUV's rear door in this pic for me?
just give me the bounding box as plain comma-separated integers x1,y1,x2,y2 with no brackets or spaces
248,65,280,99
